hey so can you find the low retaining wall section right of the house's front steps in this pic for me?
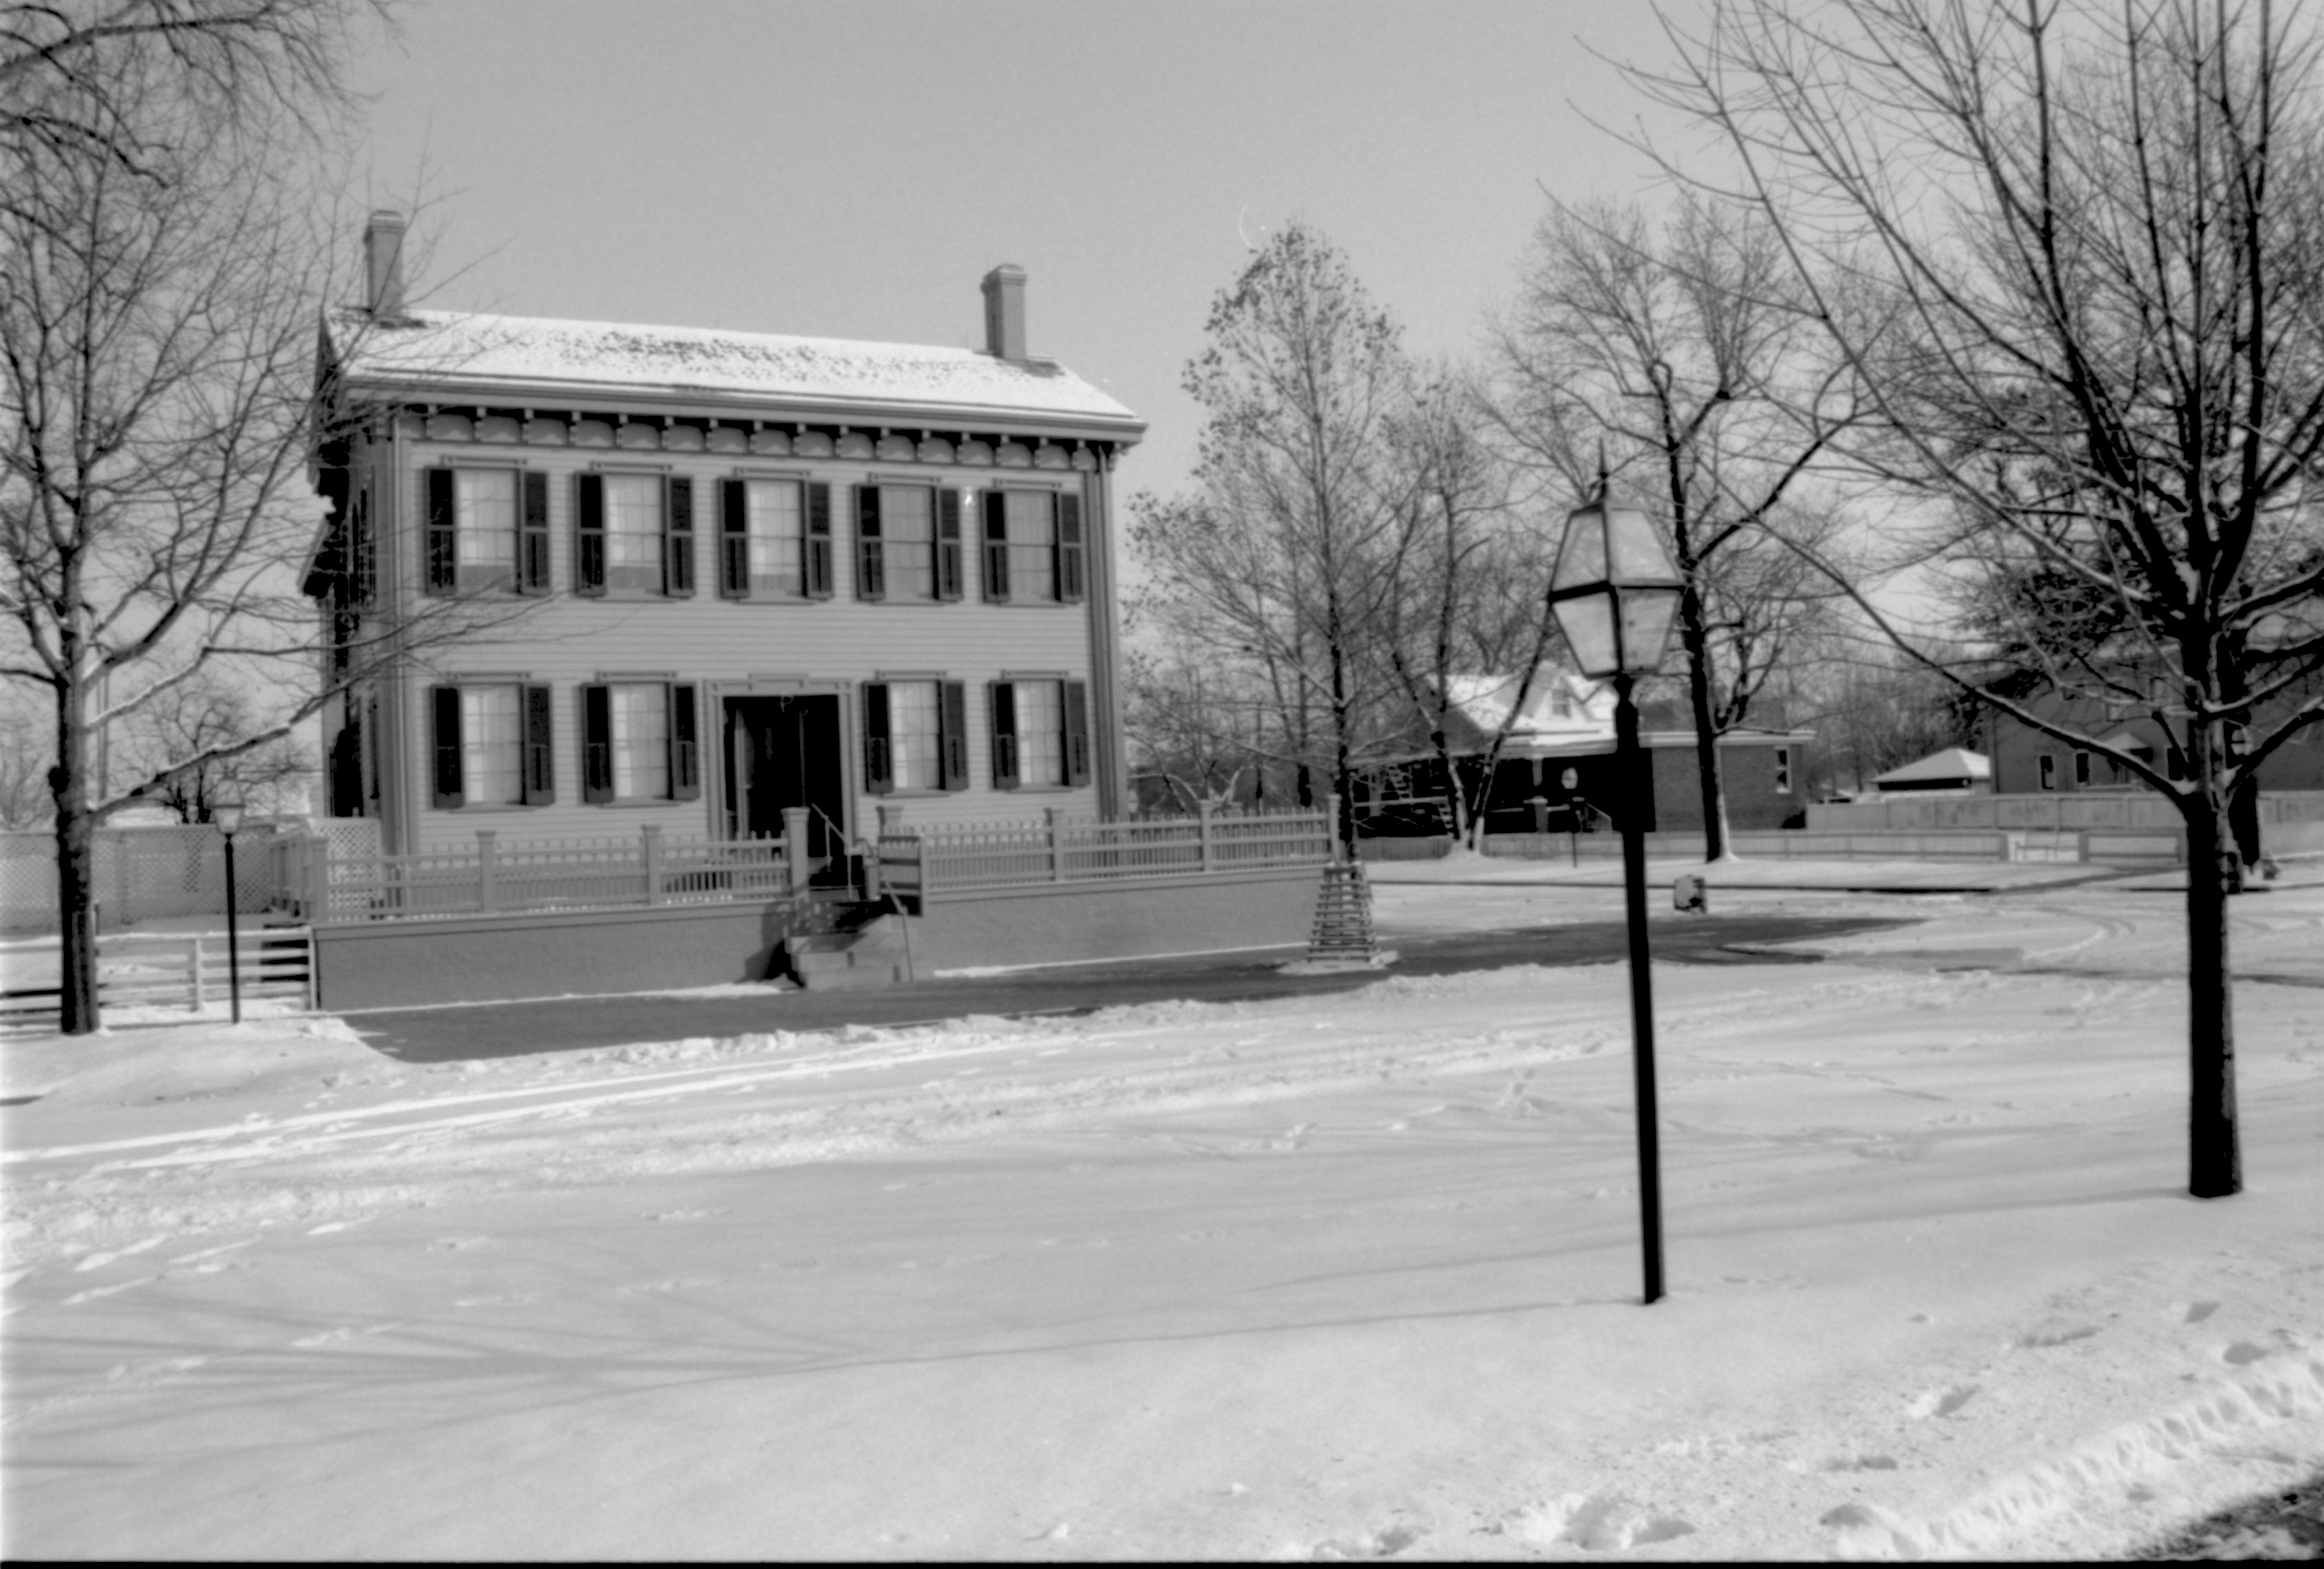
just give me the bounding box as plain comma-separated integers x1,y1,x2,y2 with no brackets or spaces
911,867,1323,977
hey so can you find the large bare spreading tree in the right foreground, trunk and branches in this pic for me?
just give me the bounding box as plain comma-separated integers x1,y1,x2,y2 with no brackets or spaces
1632,0,2324,1197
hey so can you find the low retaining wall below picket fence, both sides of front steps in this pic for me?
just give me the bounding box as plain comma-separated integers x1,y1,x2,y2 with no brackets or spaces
314,867,1323,1011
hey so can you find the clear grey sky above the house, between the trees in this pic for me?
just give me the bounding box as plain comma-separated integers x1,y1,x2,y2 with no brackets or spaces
346,0,1666,511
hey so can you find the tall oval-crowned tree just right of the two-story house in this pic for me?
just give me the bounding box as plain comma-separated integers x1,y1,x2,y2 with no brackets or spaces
1130,223,1408,843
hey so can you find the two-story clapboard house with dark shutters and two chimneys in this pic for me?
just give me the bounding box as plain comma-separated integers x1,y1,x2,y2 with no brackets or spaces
307,214,1143,888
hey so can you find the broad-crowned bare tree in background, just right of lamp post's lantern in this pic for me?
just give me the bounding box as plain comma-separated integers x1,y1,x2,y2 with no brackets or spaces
1494,197,1852,860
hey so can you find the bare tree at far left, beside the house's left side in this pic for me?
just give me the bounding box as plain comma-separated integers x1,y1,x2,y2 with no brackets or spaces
0,0,518,1035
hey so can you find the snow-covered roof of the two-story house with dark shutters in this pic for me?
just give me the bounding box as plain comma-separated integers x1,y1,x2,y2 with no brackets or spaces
330,312,1145,439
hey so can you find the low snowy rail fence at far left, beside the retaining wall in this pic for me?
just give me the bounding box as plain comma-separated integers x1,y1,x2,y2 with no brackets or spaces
0,928,314,1025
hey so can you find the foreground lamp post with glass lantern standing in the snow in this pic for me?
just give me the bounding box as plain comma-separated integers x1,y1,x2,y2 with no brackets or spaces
1550,486,1685,1301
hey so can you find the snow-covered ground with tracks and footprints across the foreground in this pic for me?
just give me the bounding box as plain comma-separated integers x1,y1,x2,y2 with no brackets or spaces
0,872,2324,1560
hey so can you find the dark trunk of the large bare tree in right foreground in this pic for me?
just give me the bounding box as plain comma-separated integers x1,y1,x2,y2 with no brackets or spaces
2180,786,2243,1199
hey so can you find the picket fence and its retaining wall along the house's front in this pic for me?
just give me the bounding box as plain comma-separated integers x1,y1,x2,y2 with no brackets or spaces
270,809,1332,1009
